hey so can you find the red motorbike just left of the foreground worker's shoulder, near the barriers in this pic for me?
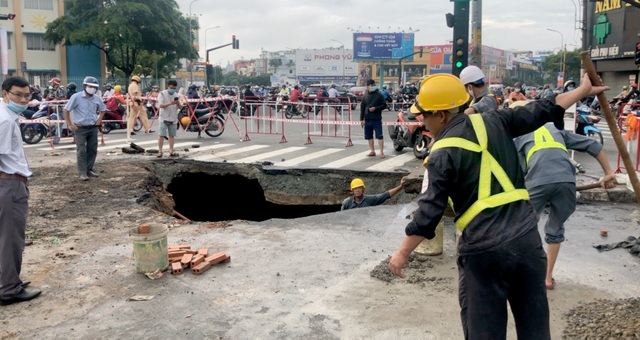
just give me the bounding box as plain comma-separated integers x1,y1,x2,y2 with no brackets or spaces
388,111,432,159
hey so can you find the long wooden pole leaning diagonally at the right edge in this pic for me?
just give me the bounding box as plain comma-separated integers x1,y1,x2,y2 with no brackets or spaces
580,51,640,204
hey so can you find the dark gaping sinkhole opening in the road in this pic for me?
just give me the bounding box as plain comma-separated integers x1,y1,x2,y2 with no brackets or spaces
167,173,340,222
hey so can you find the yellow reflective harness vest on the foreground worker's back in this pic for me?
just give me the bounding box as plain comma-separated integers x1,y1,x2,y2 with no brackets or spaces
431,115,529,231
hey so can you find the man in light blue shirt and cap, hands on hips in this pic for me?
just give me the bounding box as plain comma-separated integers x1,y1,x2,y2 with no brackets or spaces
64,76,107,181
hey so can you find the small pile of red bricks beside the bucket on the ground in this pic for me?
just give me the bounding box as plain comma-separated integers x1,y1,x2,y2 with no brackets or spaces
169,245,231,275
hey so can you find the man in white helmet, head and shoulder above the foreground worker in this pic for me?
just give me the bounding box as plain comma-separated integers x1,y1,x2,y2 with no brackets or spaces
460,65,498,115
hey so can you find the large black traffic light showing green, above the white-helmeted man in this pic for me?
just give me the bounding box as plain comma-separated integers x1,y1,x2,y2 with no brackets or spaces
448,0,469,77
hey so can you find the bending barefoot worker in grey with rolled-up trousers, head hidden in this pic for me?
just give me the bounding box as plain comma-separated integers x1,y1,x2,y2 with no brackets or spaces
510,101,616,290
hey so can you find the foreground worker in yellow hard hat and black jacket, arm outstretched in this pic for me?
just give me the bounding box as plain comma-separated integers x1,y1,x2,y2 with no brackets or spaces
389,73,608,339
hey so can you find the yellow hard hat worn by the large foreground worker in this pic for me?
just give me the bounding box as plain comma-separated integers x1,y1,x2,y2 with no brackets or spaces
409,73,469,114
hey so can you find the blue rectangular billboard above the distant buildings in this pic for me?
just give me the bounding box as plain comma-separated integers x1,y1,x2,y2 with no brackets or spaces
353,33,414,61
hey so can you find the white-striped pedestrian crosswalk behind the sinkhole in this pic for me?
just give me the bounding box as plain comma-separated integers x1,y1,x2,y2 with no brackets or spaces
25,136,422,172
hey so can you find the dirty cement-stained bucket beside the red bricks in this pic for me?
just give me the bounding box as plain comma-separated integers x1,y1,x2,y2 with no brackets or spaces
129,224,169,274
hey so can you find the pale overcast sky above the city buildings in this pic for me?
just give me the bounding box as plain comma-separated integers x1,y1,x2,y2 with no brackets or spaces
176,0,582,67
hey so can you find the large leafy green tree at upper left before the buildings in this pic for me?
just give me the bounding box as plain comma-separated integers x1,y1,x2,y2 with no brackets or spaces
44,0,198,78
